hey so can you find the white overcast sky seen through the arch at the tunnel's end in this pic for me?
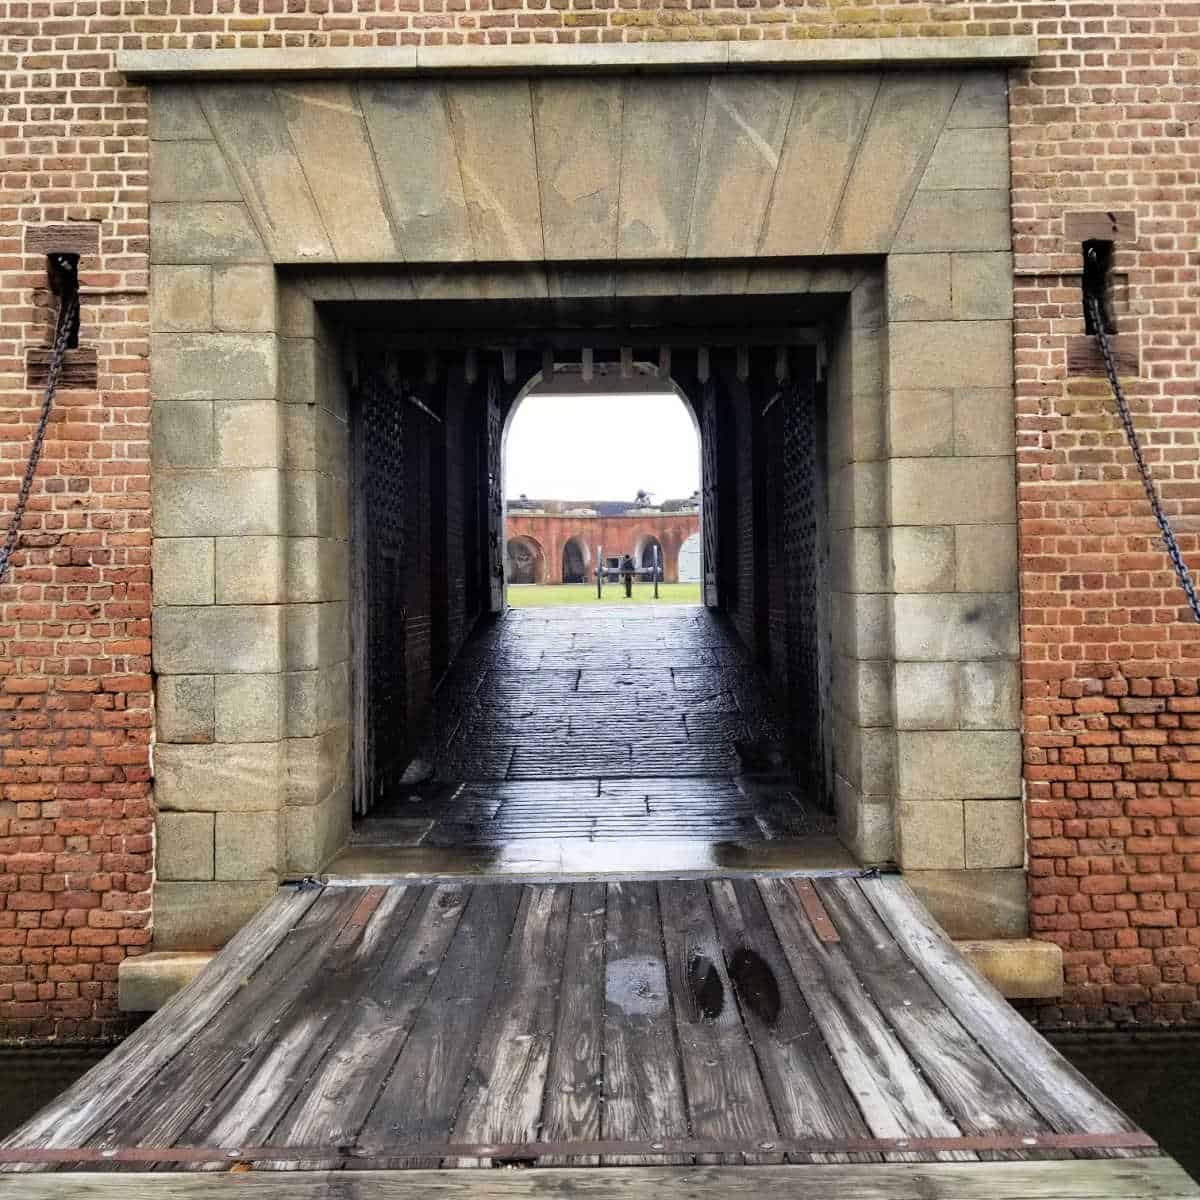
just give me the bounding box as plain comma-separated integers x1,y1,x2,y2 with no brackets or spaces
504,394,700,502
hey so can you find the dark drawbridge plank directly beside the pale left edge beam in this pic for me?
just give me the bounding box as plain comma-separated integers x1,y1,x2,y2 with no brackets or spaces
91,888,362,1146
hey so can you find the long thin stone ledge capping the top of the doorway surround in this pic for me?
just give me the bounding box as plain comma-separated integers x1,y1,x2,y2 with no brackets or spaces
116,36,1037,83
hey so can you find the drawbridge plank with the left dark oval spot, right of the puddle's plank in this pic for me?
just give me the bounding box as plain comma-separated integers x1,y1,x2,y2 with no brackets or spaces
659,880,782,1163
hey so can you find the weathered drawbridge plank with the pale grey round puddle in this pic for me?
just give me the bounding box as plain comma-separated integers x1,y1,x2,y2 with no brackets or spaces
601,883,688,1165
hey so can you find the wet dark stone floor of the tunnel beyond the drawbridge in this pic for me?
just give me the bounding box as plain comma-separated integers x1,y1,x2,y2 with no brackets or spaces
355,606,833,869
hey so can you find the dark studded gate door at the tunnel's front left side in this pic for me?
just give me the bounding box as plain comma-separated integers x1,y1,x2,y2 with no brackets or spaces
352,358,408,815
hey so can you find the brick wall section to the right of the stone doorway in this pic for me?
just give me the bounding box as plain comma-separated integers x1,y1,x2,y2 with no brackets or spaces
1009,0,1200,1022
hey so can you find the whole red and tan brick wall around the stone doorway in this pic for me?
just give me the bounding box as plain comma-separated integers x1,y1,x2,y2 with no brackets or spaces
0,0,1200,1037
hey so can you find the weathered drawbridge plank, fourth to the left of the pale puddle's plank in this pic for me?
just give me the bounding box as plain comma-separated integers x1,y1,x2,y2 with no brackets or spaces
271,883,469,1170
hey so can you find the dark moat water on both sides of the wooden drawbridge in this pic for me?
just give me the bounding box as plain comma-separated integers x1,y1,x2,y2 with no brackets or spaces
0,1033,1200,1180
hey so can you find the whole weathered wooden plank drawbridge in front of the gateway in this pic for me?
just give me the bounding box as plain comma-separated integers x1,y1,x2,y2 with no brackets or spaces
0,872,1200,1200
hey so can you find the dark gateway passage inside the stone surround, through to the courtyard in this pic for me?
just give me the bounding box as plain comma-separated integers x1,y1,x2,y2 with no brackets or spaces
348,300,834,871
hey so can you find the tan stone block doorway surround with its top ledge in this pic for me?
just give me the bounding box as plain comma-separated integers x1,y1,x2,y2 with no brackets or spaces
129,38,1033,949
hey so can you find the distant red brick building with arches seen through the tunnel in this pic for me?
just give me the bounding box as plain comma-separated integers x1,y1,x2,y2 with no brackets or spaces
505,497,701,583
